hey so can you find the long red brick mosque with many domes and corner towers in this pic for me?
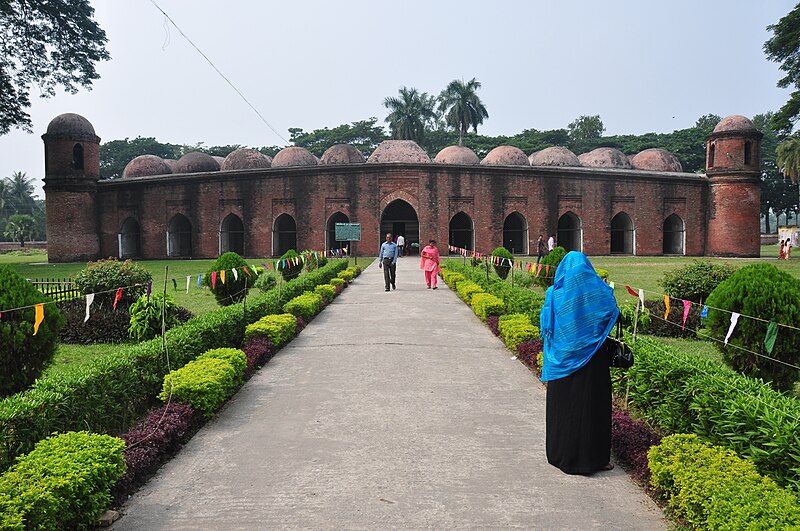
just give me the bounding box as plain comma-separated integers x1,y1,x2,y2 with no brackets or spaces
42,113,762,262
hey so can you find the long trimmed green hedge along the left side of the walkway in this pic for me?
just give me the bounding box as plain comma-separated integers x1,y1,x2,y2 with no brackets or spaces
0,260,350,470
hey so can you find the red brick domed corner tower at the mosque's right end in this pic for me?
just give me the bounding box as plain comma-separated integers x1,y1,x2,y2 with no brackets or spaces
705,115,763,257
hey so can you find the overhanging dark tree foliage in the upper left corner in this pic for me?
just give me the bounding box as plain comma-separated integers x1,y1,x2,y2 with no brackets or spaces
0,0,109,135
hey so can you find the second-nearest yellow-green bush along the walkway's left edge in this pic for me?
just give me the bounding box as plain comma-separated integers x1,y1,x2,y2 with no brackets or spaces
158,358,237,418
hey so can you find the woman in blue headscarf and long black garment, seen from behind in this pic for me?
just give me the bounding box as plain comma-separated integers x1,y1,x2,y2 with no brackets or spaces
539,251,619,474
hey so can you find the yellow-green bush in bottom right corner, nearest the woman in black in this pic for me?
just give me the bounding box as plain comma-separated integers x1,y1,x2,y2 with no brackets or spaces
648,434,800,530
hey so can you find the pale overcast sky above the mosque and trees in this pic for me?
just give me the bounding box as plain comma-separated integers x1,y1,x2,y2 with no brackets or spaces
0,0,794,196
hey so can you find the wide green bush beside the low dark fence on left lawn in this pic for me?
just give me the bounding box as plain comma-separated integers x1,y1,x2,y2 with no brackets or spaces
75,258,153,311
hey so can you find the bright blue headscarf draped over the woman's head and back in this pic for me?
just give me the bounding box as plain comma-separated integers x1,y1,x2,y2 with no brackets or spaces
539,251,619,382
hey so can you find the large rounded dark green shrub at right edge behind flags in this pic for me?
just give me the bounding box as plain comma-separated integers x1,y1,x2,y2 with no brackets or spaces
706,264,800,391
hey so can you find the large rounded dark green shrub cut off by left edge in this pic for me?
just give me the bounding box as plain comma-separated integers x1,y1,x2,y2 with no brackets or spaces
0,266,64,396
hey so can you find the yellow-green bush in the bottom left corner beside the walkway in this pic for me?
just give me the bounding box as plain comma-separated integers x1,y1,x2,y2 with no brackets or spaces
0,431,125,530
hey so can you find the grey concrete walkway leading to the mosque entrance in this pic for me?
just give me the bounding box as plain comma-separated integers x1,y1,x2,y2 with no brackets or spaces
114,257,667,531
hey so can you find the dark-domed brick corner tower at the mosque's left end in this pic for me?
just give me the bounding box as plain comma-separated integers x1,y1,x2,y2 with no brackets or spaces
42,113,100,262
